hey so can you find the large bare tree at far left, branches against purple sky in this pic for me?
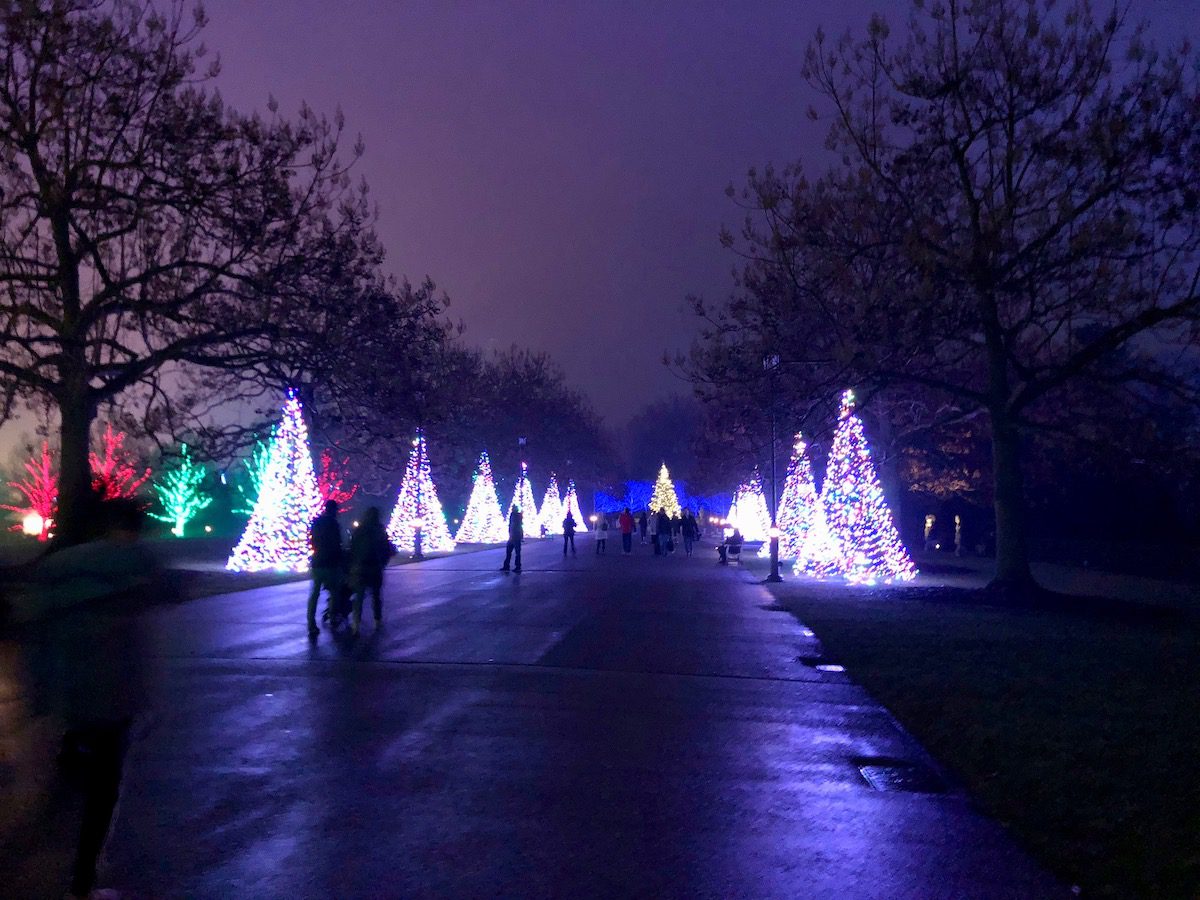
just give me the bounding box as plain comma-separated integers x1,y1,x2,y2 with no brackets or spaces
0,0,380,541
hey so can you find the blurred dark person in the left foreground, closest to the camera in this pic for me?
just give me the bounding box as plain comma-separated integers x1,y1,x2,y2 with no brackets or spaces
13,499,162,898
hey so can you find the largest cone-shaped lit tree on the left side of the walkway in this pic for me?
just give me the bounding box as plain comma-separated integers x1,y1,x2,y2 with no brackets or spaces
226,394,320,572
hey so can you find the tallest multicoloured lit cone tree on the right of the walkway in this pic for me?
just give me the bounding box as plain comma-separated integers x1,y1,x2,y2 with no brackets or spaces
822,391,917,584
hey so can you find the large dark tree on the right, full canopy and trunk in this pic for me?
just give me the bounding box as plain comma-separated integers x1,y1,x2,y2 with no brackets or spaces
691,0,1200,587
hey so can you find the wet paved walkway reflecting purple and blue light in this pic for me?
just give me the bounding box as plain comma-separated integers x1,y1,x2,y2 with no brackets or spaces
0,539,1061,900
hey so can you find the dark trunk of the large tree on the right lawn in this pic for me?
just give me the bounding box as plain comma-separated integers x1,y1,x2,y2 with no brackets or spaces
990,412,1036,593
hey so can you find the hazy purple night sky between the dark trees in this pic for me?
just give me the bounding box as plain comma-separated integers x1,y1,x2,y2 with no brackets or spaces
192,0,1200,426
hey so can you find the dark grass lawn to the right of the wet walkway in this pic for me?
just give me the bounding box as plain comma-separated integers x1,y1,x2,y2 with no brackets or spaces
773,580,1200,898
